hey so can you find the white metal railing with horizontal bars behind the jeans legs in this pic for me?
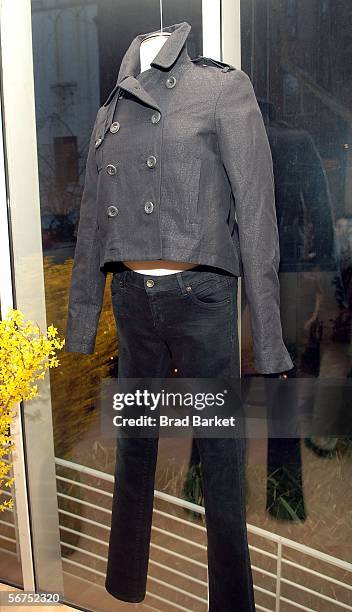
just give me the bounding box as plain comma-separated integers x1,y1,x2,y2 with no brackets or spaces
52,458,352,612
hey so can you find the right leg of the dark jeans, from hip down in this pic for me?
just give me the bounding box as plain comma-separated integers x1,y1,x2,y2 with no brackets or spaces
161,272,255,612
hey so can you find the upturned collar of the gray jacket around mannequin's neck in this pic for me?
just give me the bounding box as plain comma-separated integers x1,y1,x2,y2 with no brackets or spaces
116,21,191,86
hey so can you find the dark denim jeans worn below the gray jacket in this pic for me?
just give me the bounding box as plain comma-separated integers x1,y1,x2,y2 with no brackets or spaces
105,265,255,612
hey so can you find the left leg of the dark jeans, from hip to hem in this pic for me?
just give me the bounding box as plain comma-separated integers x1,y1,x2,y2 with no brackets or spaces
105,289,171,602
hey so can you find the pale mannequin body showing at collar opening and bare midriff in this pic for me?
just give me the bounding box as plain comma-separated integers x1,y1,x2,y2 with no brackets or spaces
123,34,198,275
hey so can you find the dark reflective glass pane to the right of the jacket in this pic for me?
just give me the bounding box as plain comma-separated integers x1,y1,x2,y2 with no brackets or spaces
241,0,352,611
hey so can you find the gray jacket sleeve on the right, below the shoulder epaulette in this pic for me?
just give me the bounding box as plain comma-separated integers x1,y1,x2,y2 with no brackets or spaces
215,70,293,374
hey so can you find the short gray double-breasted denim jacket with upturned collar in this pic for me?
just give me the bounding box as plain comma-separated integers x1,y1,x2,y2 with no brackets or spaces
65,21,293,373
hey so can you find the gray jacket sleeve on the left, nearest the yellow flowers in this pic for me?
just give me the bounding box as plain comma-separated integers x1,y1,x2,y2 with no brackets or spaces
64,109,106,354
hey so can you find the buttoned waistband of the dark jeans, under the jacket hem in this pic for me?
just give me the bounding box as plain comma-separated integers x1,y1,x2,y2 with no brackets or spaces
115,264,233,292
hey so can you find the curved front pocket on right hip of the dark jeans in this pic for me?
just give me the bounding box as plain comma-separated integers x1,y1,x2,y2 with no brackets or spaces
186,277,232,310
